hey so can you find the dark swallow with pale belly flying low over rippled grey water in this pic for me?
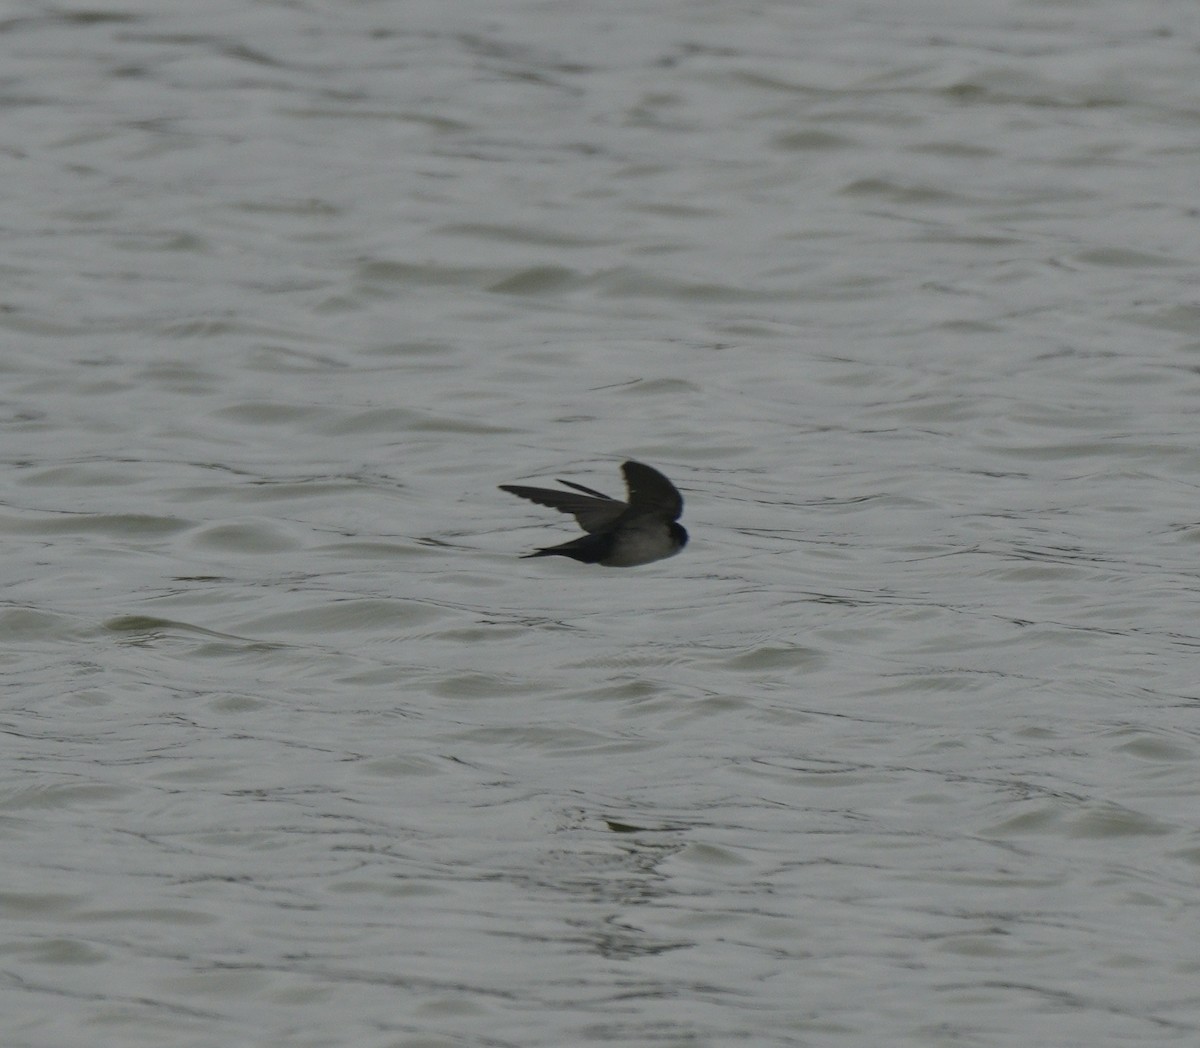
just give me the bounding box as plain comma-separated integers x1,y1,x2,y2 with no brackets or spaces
500,462,688,568
